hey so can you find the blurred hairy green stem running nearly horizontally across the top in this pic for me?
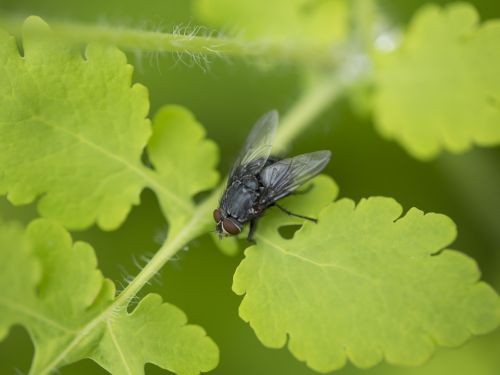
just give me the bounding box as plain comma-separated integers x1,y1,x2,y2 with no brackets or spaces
0,16,338,68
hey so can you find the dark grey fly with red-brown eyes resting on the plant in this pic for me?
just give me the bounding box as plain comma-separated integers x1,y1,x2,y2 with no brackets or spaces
213,111,331,242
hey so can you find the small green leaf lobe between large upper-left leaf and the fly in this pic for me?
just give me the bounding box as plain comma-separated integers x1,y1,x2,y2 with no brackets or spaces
148,105,219,234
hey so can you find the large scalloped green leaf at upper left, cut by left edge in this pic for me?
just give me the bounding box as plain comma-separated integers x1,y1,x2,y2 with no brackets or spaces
0,17,151,229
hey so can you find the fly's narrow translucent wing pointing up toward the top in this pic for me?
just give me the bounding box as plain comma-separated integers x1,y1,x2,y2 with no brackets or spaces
228,111,278,184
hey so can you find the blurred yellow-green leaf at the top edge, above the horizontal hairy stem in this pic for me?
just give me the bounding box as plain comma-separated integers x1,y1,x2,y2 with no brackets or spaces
194,0,349,44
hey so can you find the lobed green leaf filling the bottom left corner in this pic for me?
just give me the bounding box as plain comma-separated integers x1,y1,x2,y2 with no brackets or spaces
0,219,218,375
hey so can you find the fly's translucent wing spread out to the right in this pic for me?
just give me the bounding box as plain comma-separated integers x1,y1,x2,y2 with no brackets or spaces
260,151,331,204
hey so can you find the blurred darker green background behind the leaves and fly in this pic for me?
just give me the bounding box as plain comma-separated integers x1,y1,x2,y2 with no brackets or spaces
0,0,500,375
